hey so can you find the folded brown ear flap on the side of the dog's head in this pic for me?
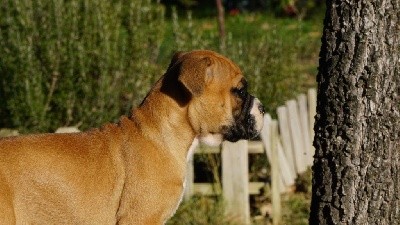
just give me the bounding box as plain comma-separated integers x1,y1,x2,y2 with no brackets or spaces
178,57,212,96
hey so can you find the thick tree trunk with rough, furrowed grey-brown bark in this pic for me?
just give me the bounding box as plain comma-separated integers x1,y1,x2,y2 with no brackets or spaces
309,0,400,225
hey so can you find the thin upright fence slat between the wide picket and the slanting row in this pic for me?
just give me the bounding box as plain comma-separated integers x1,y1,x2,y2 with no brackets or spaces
270,120,281,225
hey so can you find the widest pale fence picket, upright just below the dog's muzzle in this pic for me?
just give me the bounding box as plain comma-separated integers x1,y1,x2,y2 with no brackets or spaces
221,140,250,224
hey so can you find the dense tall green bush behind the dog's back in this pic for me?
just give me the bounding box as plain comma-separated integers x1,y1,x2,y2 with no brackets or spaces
0,0,165,131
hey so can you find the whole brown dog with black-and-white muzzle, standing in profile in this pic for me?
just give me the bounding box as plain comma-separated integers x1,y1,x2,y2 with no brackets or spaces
0,51,263,225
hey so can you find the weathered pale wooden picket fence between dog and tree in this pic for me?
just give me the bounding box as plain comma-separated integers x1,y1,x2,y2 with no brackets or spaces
185,89,316,224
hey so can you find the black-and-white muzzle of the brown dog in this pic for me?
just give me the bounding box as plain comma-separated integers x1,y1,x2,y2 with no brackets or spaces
222,95,265,142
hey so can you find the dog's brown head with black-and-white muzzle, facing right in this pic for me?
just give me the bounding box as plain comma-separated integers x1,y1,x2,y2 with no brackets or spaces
164,51,264,144
